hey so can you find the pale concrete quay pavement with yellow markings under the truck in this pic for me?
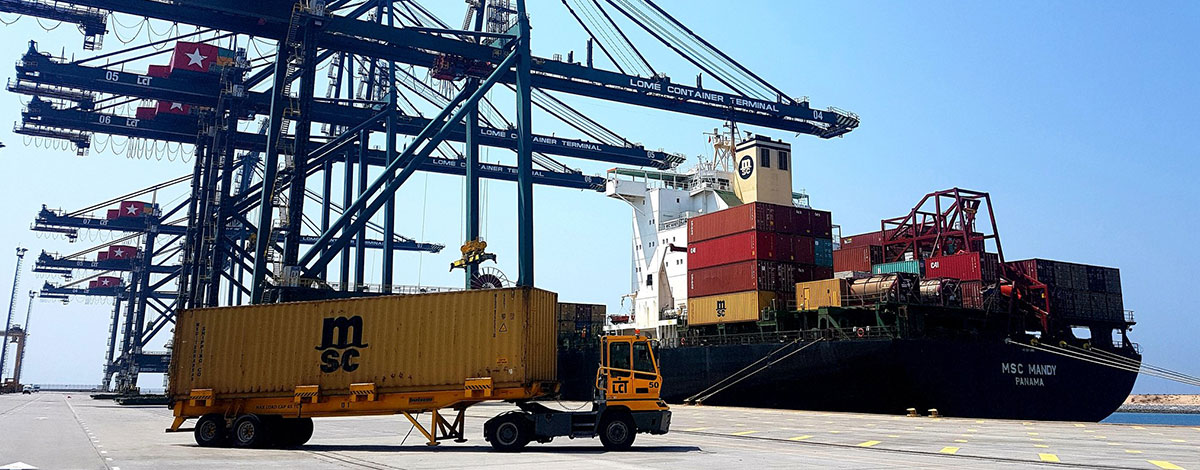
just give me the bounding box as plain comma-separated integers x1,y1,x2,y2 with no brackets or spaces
0,392,1200,470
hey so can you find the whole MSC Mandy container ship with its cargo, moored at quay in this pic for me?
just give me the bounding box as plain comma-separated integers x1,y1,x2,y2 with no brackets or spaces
559,132,1141,421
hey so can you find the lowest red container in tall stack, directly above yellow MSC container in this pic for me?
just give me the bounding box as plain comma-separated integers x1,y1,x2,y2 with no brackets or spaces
688,261,796,297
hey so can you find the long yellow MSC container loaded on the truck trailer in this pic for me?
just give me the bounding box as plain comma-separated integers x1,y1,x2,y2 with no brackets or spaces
168,288,558,399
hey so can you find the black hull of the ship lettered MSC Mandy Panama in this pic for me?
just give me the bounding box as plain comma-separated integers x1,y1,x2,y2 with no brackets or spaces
559,339,1138,422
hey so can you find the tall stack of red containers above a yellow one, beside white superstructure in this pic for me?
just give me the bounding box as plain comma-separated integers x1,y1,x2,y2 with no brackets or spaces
688,203,833,325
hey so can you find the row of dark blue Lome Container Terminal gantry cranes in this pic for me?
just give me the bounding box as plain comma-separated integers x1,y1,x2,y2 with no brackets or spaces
0,0,859,390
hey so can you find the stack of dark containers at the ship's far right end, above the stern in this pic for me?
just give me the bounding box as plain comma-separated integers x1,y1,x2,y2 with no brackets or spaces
1008,259,1124,323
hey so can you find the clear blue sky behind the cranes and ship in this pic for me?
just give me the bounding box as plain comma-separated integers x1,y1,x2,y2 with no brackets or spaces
0,0,1200,393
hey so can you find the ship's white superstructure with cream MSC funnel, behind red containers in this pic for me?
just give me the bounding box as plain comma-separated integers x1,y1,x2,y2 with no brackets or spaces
605,132,808,342
